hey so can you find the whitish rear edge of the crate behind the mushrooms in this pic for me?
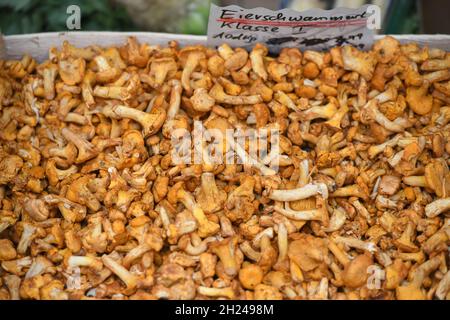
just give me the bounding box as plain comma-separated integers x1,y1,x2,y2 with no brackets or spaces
0,31,450,61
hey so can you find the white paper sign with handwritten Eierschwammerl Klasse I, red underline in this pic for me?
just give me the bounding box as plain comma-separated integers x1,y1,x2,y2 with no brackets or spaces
208,4,374,52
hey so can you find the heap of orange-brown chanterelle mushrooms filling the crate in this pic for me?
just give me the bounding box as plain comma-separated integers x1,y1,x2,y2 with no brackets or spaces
0,37,450,299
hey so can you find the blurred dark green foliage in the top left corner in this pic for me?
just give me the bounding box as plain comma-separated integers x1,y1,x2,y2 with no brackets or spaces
0,0,137,34
